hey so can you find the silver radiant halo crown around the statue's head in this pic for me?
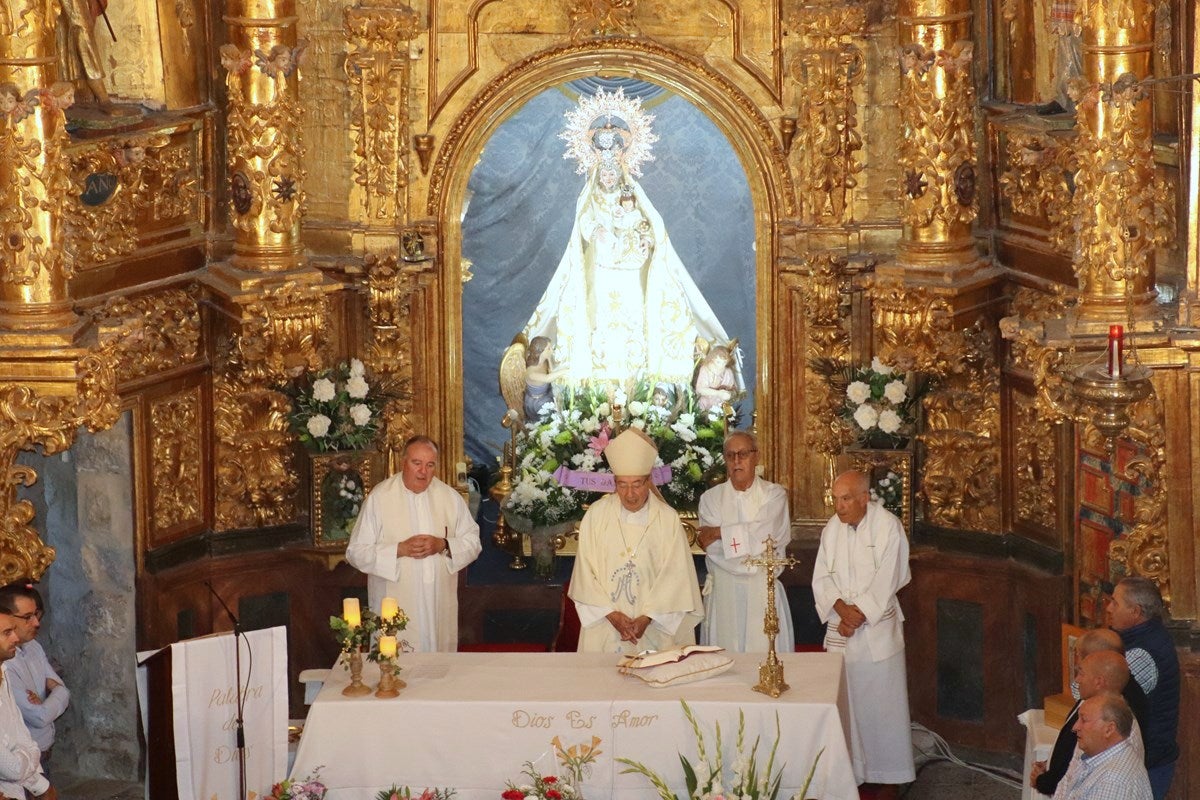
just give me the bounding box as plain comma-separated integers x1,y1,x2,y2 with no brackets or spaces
558,86,659,178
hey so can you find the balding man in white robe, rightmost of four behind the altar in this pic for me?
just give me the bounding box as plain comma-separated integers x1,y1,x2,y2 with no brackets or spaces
812,471,916,783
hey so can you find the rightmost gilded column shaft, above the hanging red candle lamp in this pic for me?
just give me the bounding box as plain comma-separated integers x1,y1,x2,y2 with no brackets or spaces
1074,0,1168,323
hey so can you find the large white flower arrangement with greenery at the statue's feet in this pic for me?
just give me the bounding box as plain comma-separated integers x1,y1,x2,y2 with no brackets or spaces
504,383,725,527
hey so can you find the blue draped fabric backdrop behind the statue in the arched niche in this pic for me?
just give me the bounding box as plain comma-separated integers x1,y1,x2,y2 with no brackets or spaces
462,79,756,467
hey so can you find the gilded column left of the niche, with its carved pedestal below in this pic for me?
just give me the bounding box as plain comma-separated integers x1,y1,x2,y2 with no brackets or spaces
208,0,340,530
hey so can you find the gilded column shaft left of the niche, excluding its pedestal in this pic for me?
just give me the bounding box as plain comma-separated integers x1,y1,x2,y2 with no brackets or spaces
221,0,305,272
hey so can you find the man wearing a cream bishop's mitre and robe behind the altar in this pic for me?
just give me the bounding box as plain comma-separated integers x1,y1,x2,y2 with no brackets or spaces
569,428,703,652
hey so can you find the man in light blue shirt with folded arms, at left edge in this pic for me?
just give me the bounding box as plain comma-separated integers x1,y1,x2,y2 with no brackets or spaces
0,583,71,765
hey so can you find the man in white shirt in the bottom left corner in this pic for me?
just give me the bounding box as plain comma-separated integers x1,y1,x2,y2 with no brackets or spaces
0,597,59,800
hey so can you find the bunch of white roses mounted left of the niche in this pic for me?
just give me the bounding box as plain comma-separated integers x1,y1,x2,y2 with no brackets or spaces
287,359,386,452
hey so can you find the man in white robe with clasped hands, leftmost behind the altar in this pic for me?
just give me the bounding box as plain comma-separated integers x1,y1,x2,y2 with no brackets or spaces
346,437,482,652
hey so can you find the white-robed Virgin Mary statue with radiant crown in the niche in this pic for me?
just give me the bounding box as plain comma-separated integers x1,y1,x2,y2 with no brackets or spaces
524,89,728,384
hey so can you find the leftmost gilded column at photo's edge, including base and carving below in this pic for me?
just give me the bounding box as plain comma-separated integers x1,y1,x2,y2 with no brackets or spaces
0,2,116,583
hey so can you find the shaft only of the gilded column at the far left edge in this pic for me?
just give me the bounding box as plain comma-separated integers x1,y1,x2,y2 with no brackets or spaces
0,4,79,331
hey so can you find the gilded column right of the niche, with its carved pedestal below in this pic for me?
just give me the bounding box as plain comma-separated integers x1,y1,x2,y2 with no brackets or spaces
871,0,1001,533
